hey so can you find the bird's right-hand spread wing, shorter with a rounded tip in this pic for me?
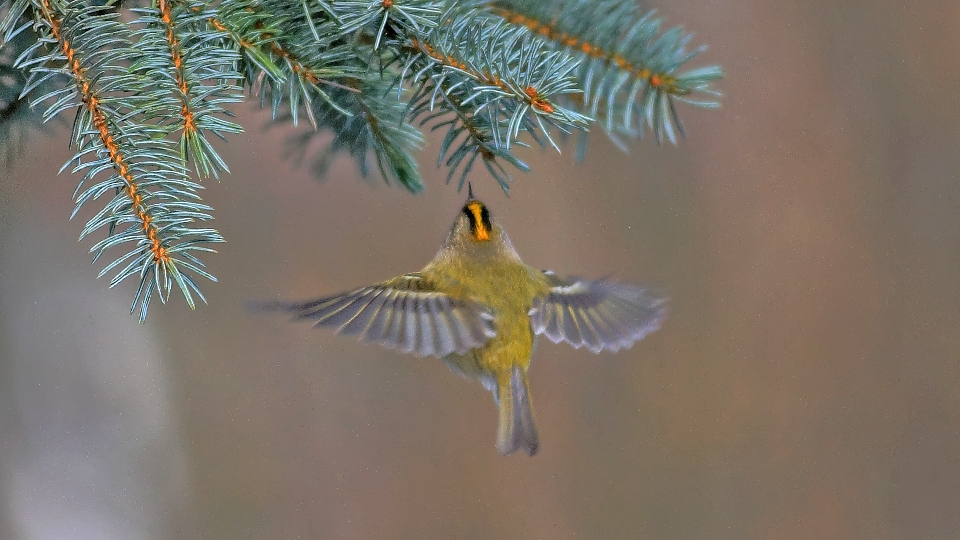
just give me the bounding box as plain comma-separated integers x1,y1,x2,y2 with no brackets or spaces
530,272,666,353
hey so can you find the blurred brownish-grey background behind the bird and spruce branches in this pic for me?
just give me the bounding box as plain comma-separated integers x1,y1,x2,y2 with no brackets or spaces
0,0,960,540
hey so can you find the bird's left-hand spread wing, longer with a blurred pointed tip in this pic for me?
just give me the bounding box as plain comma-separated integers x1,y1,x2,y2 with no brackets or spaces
253,273,495,358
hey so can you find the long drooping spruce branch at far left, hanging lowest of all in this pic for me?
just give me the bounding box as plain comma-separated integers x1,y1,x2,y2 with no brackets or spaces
8,0,223,320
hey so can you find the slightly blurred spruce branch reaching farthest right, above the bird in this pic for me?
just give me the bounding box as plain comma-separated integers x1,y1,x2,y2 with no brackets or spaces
489,0,723,144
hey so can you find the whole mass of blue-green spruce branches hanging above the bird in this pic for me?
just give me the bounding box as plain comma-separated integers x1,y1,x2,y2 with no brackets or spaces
0,0,722,321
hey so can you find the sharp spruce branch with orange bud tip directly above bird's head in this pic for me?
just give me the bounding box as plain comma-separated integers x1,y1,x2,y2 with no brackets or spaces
397,9,589,192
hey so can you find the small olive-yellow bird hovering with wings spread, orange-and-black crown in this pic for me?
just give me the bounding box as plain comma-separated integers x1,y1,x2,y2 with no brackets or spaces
251,185,666,456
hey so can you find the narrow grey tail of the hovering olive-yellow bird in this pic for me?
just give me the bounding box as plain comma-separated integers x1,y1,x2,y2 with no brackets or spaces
497,367,540,456
